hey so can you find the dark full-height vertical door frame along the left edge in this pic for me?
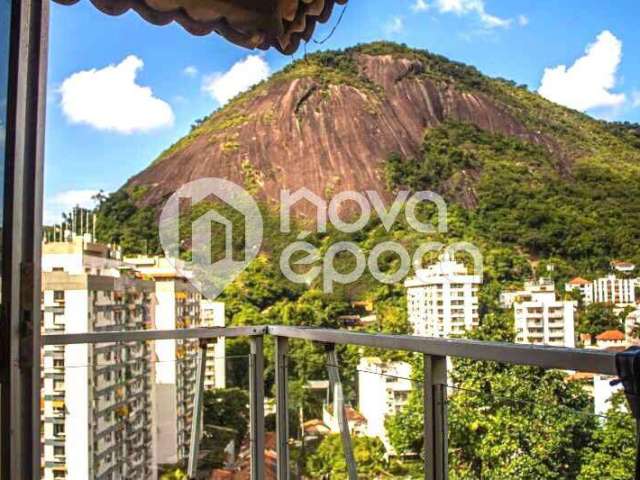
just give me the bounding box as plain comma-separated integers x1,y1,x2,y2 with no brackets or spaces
0,0,49,480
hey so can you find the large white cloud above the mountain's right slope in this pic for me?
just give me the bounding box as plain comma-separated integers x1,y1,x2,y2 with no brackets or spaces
538,30,625,111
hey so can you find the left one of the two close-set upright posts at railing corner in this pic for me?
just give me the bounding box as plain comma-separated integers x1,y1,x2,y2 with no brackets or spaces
249,336,265,480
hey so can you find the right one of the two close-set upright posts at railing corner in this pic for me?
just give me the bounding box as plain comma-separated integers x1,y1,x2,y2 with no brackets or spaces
276,337,289,480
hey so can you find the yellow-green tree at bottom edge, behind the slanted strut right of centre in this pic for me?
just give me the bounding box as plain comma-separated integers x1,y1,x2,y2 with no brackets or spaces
306,434,391,480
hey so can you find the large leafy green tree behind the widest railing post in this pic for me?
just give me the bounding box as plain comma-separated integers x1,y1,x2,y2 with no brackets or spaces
387,314,595,480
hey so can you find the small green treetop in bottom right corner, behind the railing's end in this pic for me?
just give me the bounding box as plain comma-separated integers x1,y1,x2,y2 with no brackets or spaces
578,393,636,480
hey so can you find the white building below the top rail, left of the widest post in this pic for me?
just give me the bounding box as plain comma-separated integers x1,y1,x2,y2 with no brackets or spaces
358,357,413,454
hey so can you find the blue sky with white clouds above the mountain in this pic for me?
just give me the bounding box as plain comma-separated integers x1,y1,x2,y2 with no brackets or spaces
45,0,640,222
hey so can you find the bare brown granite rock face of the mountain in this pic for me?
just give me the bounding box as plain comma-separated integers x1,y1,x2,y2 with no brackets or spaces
125,53,561,215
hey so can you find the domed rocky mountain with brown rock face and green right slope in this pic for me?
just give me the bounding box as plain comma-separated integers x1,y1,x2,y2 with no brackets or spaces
97,42,640,268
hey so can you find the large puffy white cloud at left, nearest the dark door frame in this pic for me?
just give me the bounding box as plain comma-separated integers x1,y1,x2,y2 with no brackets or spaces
60,55,174,134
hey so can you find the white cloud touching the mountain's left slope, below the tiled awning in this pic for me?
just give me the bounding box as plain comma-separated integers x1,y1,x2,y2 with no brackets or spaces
202,55,271,105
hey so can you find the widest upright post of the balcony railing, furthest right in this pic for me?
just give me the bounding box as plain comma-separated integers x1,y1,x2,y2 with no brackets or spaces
423,355,449,480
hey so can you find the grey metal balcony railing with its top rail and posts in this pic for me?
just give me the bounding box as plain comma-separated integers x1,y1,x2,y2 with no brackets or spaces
43,326,629,480
